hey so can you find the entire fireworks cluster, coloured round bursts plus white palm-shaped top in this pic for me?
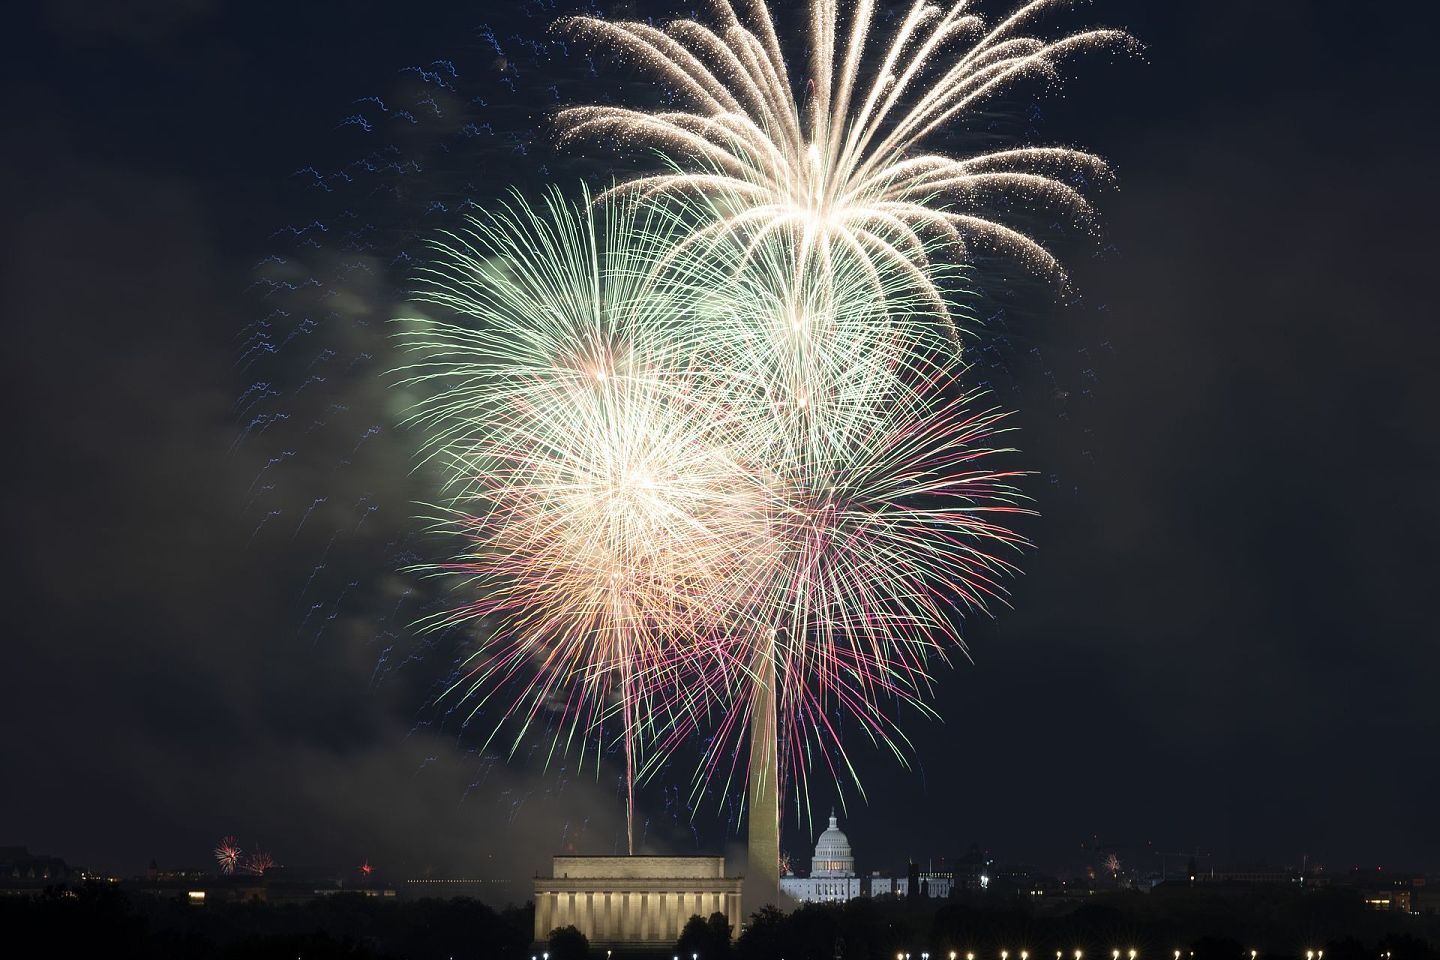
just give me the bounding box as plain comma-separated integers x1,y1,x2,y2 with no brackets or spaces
400,0,1129,871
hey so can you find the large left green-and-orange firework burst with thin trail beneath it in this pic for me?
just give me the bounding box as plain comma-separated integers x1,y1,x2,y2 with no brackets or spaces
400,184,769,849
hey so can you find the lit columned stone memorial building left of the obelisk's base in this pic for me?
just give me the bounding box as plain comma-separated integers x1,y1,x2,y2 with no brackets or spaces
534,856,742,946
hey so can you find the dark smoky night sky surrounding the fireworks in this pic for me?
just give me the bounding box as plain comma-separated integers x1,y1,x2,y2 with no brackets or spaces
0,0,1440,877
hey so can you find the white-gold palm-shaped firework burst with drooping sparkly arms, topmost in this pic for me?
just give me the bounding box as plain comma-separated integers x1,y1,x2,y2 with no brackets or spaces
557,0,1132,306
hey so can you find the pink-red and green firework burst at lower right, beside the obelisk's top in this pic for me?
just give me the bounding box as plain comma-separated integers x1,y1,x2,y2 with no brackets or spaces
673,397,1028,811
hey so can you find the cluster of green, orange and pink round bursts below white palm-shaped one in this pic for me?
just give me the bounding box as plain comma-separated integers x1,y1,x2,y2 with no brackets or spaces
402,185,1022,829
